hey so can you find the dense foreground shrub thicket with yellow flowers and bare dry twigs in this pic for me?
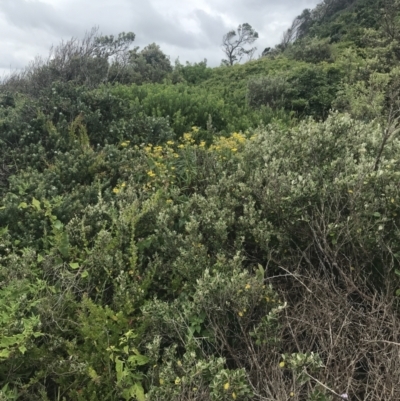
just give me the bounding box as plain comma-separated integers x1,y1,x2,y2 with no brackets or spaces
0,114,400,400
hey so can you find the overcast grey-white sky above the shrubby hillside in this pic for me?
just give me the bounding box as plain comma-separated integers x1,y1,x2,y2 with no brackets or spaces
0,0,321,75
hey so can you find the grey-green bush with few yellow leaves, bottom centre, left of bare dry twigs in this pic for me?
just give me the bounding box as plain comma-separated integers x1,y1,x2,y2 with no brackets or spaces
143,266,283,400
